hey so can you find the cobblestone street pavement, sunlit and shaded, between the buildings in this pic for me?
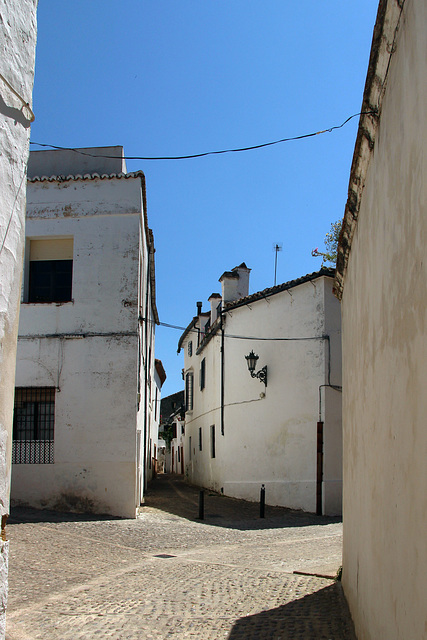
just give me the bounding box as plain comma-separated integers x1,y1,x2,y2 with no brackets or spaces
6,476,355,640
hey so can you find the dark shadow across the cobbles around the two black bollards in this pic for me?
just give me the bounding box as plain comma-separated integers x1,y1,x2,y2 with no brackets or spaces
145,474,341,530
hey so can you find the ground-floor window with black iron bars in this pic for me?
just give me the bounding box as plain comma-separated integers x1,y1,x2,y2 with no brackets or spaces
12,387,55,464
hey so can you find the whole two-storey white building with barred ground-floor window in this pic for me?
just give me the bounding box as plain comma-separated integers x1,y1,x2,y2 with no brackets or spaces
12,147,158,517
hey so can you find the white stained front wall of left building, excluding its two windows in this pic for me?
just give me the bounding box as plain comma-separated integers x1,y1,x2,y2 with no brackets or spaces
12,171,154,517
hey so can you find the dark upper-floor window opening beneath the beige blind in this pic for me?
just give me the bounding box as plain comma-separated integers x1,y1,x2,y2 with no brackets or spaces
28,260,73,302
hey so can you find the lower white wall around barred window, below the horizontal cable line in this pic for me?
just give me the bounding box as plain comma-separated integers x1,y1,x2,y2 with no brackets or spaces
11,336,137,517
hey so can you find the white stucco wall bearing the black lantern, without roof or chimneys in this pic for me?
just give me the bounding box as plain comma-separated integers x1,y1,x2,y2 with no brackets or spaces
184,278,341,513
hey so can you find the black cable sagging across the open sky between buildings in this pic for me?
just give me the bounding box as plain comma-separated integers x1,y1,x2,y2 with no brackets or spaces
30,110,377,160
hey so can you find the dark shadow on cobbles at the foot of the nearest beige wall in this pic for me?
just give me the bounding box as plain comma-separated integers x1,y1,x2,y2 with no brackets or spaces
228,583,356,640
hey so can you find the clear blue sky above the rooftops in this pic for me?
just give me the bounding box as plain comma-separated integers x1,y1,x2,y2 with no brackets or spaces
31,0,378,395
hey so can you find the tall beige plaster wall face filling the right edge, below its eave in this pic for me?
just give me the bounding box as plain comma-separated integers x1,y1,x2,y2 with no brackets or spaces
342,0,427,640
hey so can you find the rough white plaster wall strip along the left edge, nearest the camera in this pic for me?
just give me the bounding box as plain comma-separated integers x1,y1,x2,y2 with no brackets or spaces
0,0,37,638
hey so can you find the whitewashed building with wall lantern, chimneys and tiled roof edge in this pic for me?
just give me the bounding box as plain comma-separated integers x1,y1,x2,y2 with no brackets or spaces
178,264,342,514
